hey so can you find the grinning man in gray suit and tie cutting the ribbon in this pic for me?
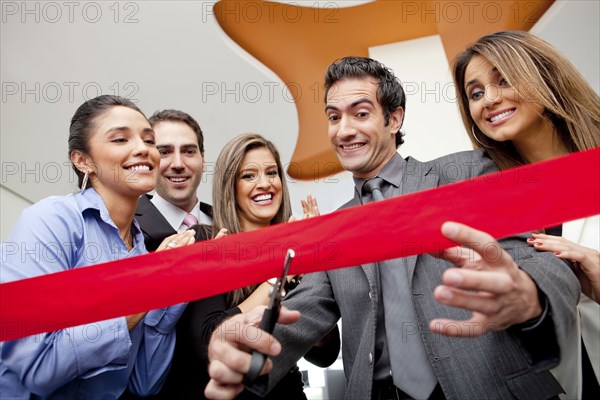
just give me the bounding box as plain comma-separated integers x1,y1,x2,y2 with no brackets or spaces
206,57,580,400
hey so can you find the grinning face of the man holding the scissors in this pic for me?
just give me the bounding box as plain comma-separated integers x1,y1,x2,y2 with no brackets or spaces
325,78,403,179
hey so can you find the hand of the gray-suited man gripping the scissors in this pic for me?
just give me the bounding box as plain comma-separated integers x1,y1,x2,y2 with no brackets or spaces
204,306,300,399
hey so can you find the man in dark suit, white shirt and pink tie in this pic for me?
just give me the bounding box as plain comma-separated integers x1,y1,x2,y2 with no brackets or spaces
135,110,212,251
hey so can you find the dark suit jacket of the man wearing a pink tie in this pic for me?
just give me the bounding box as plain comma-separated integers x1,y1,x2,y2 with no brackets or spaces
135,194,212,251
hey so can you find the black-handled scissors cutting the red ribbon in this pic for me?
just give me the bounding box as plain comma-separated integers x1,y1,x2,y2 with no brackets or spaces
244,249,296,386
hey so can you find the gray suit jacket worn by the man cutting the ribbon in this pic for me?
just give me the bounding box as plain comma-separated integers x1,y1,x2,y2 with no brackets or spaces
257,151,580,400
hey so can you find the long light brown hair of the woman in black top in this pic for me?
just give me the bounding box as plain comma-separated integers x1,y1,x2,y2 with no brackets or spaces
212,133,292,307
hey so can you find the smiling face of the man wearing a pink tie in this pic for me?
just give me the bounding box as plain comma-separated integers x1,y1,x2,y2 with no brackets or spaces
154,121,205,212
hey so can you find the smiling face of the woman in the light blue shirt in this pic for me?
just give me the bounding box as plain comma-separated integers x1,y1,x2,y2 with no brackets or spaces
85,106,160,202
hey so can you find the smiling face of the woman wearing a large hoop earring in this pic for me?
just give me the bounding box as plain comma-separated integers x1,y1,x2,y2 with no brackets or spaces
465,55,553,146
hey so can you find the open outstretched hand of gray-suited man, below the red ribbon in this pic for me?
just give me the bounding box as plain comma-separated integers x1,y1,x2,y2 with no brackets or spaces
429,222,542,337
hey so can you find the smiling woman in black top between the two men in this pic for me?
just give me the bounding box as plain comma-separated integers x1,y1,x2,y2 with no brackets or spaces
155,134,340,400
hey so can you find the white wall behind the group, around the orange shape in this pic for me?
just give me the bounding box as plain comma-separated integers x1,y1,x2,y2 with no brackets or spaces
0,0,600,240
